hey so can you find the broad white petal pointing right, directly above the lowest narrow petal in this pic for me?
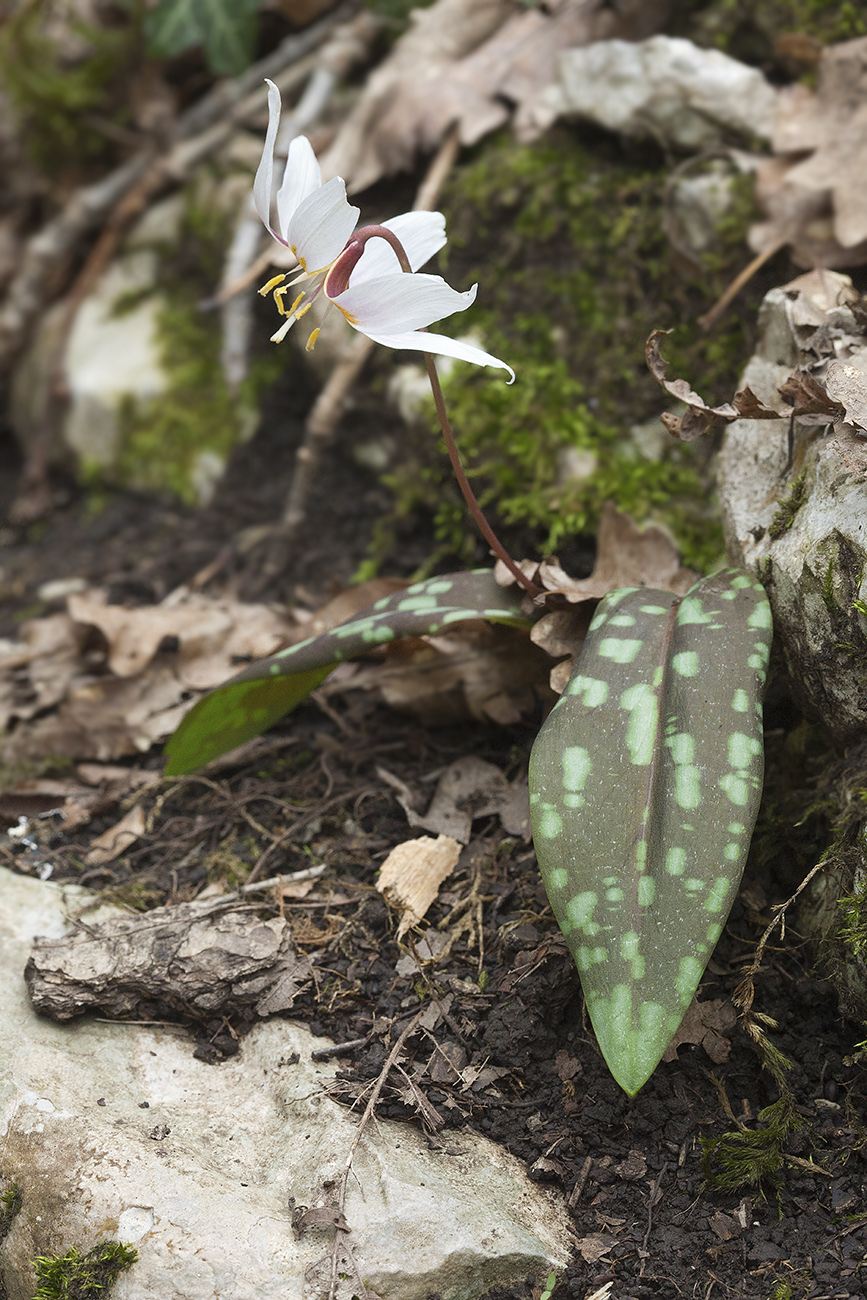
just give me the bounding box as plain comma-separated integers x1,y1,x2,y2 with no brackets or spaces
331,273,478,334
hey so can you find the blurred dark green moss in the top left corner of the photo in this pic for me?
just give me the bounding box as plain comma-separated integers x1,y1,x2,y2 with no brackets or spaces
0,0,142,172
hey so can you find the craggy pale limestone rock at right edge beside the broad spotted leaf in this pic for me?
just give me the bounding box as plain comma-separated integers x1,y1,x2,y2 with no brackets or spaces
718,270,867,738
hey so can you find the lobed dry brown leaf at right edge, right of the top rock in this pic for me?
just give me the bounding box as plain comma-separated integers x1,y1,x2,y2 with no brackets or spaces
749,36,867,268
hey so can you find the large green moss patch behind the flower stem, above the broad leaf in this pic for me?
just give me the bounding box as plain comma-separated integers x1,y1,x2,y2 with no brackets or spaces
380,129,760,568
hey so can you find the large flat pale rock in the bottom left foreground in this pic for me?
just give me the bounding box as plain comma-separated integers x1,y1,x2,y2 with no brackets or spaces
0,868,571,1300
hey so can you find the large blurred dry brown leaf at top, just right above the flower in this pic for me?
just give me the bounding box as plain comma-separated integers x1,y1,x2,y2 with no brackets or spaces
322,0,662,192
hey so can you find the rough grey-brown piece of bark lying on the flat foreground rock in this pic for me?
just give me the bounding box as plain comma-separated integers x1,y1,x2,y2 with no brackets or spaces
25,904,309,1023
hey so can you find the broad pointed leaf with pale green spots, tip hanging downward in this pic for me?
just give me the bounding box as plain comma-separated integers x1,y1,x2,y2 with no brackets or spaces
530,569,771,1096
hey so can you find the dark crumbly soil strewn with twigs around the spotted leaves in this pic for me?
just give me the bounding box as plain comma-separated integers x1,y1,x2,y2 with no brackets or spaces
0,418,867,1300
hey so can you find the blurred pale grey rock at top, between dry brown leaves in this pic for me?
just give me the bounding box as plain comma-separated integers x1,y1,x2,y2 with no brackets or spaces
546,36,777,150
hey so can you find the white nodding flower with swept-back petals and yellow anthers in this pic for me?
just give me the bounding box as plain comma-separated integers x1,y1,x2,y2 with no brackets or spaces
253,82,515,382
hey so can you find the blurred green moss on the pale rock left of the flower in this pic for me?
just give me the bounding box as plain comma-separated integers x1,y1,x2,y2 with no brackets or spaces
111,176,281,503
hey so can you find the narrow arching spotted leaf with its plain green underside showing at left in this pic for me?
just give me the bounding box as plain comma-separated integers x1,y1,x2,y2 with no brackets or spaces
159,569,532,776
